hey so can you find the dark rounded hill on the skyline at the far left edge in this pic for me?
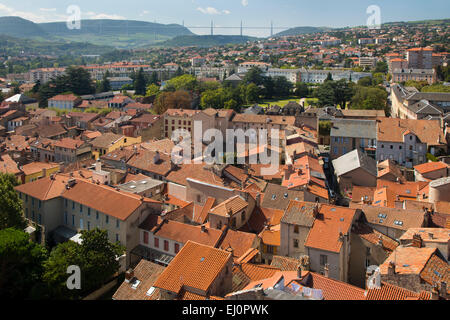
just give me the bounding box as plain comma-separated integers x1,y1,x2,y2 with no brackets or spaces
0,17,46,38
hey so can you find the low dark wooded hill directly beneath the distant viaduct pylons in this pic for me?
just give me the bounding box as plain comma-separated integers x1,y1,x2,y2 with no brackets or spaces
160,35,257,47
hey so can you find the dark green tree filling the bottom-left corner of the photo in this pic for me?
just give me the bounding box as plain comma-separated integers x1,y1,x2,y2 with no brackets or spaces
0,228,47,299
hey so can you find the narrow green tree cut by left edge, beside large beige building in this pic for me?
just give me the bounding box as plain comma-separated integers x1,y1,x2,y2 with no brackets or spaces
0,173,27,230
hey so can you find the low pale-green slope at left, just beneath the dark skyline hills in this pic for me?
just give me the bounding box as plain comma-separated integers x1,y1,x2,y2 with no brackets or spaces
0,35,114,56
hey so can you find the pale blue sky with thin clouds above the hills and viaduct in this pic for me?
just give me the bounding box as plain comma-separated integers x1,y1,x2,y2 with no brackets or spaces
0,0,450,36
